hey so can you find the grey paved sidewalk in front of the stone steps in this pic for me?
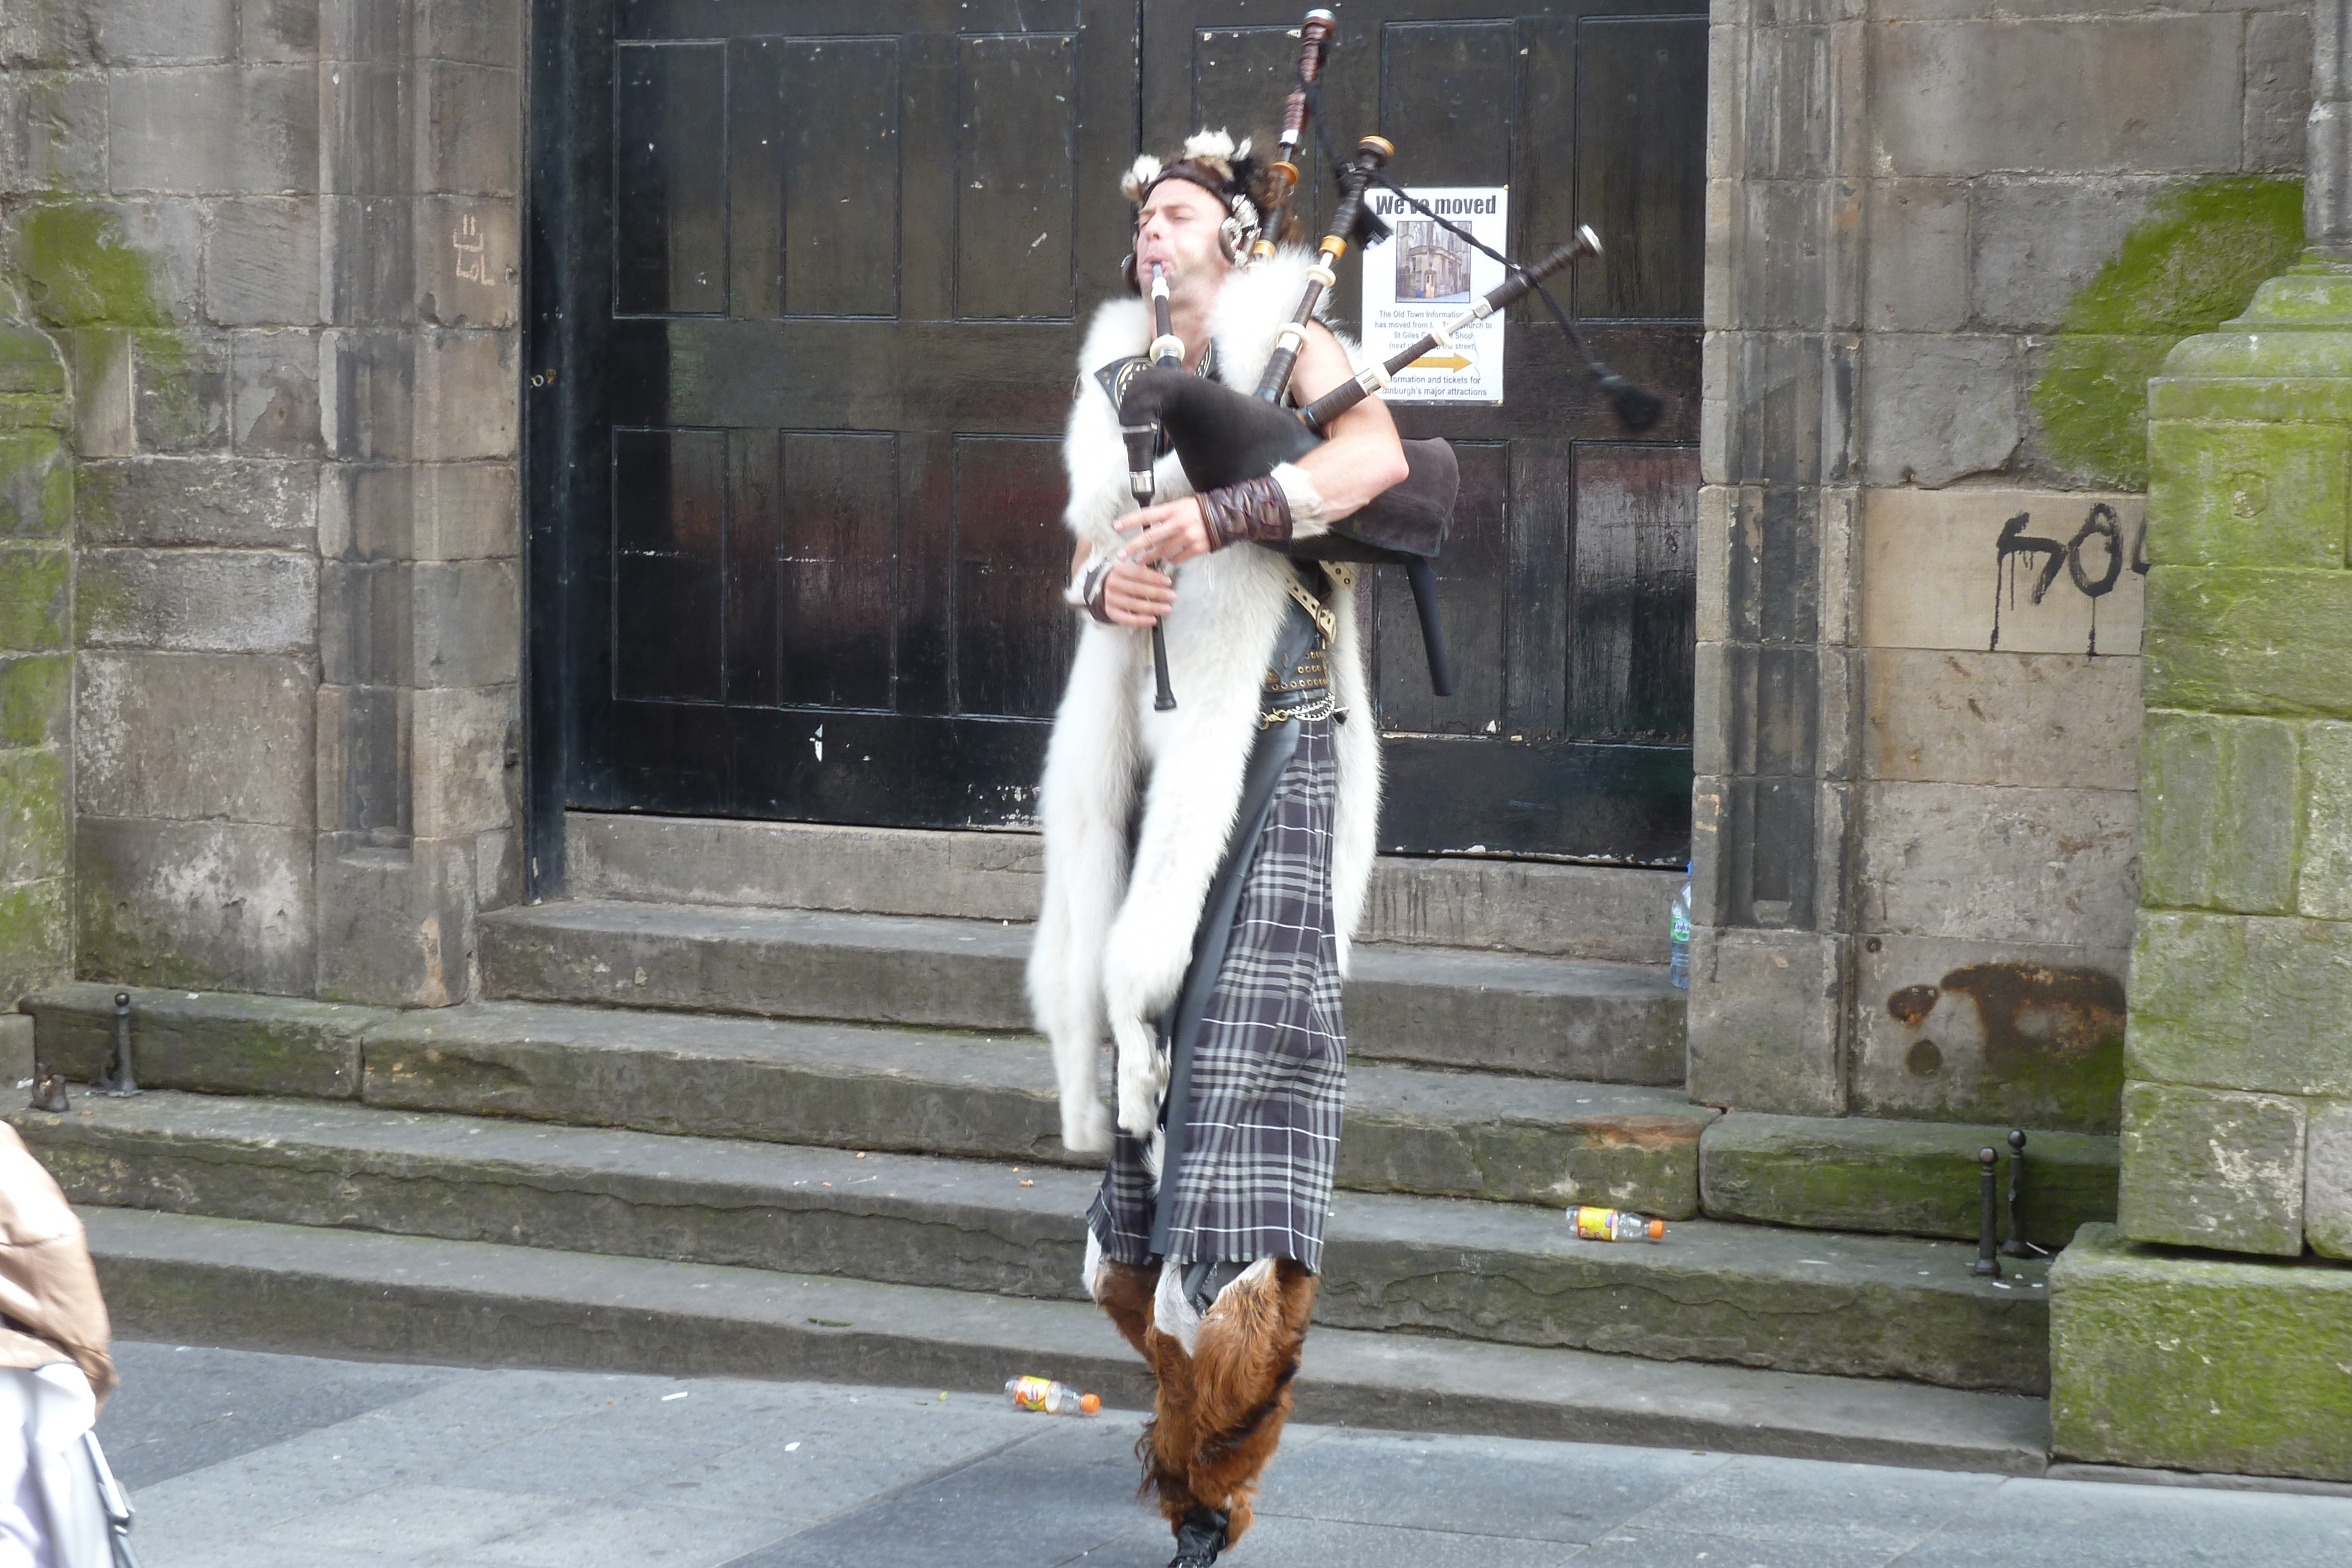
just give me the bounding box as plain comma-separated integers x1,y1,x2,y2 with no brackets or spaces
87,1345,2352,1568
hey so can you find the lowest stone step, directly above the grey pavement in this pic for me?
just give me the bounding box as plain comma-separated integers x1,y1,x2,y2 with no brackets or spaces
82,1208,2049,1474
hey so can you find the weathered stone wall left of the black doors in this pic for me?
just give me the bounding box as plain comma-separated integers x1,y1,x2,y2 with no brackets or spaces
0,0,522,1004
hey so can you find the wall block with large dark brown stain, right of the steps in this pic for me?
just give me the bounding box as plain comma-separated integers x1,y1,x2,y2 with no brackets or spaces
1846,935,2129,1133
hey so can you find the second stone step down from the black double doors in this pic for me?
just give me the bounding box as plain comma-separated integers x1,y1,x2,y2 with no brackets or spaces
480,900,1684,1084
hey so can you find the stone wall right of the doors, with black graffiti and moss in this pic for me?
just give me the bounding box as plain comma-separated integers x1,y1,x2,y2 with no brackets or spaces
1691,0,2310,1131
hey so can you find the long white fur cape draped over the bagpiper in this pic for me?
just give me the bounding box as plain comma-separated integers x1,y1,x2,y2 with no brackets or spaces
1028,252,1381,1152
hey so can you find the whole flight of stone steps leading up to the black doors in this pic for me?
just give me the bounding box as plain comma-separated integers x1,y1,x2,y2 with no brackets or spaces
12,818,2079,1472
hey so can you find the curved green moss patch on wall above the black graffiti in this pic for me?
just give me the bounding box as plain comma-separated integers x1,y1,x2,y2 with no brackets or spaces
2032,179,2303,489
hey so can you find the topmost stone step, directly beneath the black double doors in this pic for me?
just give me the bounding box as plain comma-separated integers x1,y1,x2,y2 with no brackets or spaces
564,811,1682,964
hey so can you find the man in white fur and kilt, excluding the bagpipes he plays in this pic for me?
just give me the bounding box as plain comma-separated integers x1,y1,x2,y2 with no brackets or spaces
1028,132,1406,1568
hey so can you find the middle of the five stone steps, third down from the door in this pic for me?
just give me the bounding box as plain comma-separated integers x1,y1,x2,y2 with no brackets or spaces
26,982,1719,1220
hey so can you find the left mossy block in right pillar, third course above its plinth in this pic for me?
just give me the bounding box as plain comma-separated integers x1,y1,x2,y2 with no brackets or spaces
2140,710,2303,914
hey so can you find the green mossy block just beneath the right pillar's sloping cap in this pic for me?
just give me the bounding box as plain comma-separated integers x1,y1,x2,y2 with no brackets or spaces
2147,419,2352,569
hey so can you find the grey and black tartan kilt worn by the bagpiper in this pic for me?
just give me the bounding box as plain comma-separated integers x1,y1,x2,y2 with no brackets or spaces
1087,715,1369,1272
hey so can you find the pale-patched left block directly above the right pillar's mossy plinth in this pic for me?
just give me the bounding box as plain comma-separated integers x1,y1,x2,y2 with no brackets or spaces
2117,1081,2303,1258
